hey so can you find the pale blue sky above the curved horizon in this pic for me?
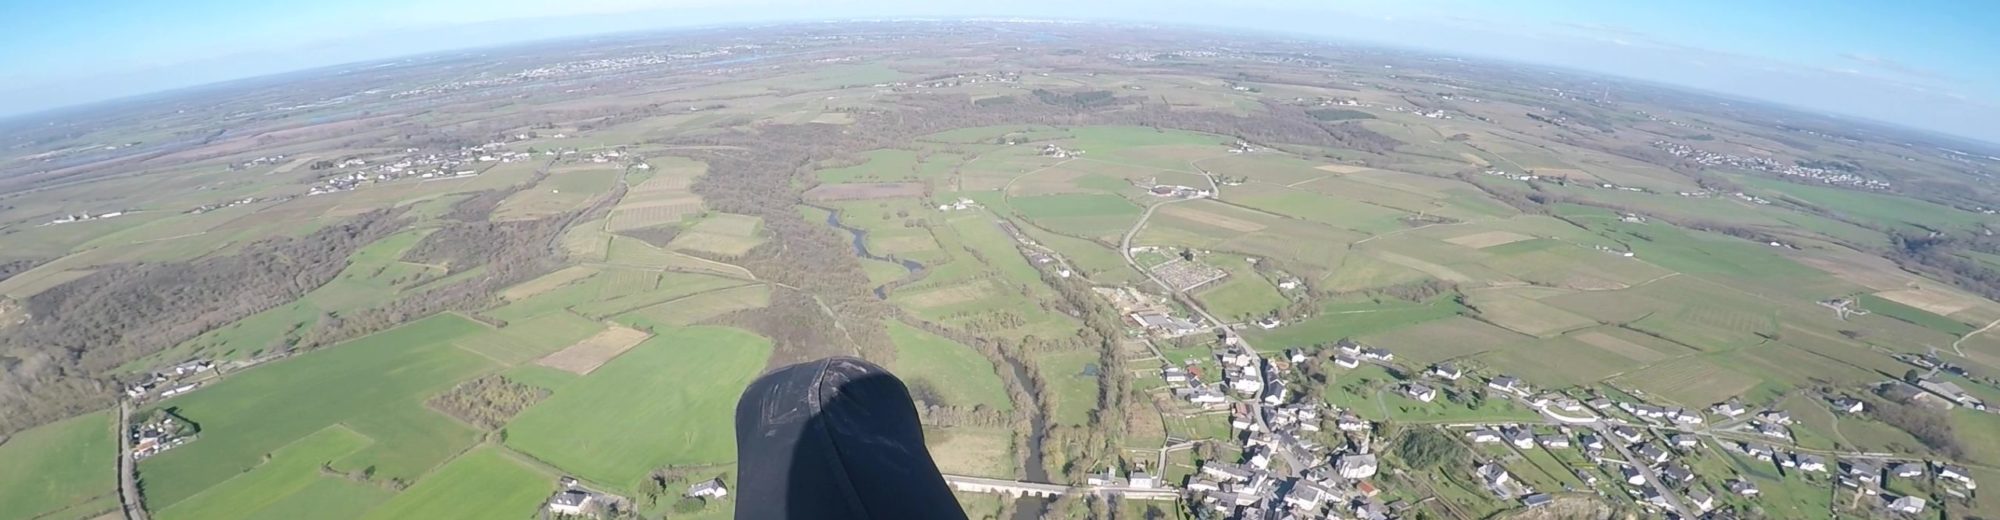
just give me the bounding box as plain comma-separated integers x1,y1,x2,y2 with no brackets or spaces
0,0,2000,142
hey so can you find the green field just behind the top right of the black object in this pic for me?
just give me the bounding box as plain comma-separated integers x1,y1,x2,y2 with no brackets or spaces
888,320,1014,410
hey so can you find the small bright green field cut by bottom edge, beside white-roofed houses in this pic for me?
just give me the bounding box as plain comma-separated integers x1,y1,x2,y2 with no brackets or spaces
364,448,556,520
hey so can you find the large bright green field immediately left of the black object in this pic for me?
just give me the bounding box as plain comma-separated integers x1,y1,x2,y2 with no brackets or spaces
506,326,770,486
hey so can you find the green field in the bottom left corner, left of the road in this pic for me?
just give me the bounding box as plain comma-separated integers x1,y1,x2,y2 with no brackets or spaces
0,410,118,520
